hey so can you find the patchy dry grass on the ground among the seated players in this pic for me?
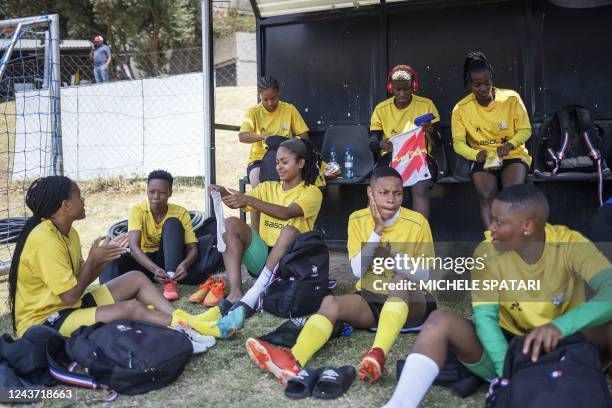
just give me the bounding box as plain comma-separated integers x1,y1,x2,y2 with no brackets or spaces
0,260,484,408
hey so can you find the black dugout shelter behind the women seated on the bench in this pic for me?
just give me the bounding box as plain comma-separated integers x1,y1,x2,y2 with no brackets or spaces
244,0,612,244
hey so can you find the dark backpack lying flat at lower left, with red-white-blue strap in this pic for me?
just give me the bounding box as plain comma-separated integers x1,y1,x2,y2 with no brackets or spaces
47,320,193,395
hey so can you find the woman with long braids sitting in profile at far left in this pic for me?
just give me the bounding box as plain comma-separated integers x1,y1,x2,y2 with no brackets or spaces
9,176,237,342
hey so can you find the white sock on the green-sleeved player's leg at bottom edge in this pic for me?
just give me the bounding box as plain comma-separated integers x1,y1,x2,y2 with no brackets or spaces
383,353,440,408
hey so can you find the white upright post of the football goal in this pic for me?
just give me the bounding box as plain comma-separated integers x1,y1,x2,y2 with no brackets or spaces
49,14,64,176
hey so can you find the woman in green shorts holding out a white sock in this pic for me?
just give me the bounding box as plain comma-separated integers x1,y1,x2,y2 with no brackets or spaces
210,138,323,315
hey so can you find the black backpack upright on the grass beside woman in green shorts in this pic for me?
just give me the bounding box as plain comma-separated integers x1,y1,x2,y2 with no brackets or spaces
263,231,329,317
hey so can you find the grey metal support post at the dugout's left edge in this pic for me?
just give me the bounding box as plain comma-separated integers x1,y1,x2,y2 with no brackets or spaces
200,0,215,217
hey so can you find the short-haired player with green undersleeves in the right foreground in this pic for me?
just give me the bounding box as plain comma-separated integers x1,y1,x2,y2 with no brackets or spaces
383,184,612,408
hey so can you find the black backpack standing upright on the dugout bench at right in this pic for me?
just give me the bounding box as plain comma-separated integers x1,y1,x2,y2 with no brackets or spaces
536,105,609,205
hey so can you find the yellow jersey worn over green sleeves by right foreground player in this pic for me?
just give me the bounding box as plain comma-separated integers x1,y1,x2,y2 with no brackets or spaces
472,224,612,335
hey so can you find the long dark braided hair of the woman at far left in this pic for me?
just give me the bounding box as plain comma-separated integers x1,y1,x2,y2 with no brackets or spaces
8,176,72,330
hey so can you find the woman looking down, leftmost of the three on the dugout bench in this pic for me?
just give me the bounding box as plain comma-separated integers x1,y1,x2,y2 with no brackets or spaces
238,76,308,231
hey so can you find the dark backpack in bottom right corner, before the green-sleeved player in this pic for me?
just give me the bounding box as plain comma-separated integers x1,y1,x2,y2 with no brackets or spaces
486,332,612,408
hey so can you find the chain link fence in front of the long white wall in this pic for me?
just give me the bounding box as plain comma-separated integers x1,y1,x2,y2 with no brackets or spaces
0,31,257,269
